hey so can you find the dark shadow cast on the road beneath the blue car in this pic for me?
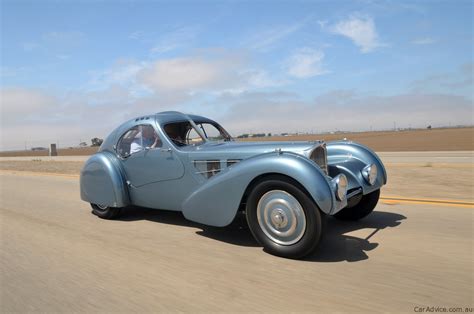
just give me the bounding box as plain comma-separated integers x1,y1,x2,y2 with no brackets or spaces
117,207,406,262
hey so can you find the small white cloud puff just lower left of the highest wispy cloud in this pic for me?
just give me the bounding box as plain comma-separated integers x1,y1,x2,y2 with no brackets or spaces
286,48,328,78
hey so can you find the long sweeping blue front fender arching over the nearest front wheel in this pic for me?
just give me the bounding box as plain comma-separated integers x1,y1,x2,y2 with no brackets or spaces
182,152,336,227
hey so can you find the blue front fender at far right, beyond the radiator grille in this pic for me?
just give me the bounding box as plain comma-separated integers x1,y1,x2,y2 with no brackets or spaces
326,141,387,195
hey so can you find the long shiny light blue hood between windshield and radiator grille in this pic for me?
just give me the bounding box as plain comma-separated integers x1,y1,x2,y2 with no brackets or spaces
185,141,324,159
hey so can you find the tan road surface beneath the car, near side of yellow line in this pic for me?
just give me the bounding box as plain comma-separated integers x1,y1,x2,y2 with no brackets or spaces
0,173,474,313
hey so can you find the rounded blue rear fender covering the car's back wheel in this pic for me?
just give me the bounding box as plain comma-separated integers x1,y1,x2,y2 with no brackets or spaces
80,152,130,207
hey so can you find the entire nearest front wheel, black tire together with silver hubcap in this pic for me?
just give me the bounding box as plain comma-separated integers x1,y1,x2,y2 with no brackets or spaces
246,176,323,258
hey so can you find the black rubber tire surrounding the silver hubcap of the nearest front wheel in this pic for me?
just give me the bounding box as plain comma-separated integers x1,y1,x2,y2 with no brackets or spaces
246,175,323,258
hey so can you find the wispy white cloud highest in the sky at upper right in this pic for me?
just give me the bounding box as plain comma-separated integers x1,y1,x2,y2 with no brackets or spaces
330,15,383,53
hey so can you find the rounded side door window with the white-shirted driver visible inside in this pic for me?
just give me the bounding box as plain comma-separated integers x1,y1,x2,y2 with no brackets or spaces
117,124,162,158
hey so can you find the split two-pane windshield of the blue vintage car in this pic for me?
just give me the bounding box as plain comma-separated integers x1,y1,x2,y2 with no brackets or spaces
164,121,232,146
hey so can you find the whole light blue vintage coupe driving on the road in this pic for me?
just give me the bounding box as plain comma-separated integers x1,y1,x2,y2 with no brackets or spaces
80,111,387,258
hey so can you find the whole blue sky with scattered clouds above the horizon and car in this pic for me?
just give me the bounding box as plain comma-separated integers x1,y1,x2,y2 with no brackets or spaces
0,1,473,148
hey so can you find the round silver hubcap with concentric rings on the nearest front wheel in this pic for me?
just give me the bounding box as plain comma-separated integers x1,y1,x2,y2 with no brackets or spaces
257,190,306,245
